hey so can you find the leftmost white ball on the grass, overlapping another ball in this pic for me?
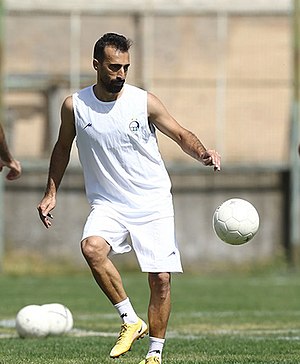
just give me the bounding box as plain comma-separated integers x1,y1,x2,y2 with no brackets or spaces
16,305,49,338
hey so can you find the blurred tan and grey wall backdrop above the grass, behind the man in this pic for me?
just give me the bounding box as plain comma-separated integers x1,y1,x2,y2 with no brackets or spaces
0,0,300,271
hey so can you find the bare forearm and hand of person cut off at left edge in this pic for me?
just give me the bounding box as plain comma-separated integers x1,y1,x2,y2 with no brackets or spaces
0,123,22,181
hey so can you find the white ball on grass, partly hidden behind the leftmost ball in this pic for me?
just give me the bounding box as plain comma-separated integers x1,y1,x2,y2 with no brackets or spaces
41,303,73,335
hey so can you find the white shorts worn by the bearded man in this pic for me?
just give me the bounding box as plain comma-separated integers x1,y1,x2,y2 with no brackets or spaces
82,206,182,273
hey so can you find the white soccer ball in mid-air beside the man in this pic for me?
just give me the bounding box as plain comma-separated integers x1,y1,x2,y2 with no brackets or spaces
213,198,259,245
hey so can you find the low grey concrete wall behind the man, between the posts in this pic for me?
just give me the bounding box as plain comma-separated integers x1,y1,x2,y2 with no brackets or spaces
5,167,286,269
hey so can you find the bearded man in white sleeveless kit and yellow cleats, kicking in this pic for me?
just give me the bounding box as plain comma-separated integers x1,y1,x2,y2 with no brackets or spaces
38,33,220,364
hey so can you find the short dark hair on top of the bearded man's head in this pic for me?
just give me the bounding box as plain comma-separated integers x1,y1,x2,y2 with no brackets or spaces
93,33,132,62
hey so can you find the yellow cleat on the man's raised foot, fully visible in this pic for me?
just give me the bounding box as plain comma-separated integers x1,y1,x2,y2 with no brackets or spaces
110,318,148,363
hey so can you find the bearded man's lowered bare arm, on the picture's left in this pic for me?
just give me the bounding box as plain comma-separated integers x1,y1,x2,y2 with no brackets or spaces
37,96,76,228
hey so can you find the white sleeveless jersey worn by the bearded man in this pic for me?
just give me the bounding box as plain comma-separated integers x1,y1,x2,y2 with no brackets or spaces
73,84,173,221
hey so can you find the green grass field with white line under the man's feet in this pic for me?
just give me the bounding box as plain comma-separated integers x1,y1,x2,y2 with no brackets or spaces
0,272,300,364
